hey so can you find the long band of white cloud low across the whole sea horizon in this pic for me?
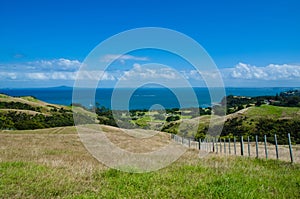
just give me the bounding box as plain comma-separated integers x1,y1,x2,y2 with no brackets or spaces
0,58,300,87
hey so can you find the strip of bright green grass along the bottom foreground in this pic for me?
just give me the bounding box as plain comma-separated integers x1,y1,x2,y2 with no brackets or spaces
0,156,300,198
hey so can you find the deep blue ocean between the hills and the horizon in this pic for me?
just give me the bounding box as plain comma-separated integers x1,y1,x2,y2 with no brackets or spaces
0,87,295,110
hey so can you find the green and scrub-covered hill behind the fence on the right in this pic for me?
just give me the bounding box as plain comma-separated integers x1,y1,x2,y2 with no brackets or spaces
163,105,300,144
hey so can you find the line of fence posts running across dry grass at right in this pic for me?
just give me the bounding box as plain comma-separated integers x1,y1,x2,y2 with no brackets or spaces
171,134,300,163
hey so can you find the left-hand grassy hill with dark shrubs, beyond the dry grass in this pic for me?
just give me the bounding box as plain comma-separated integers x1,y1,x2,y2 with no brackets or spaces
0,94,96,130
